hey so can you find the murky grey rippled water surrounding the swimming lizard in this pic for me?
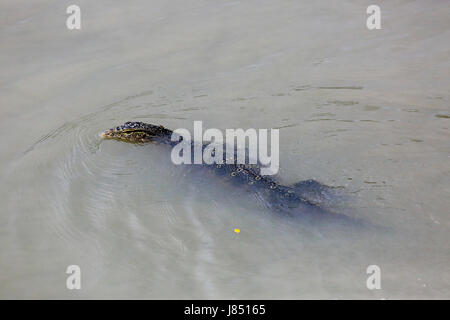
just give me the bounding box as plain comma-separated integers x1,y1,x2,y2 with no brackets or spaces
0,0,450,299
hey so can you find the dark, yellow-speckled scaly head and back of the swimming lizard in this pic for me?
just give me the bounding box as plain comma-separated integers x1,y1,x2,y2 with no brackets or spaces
102,122,342,218
